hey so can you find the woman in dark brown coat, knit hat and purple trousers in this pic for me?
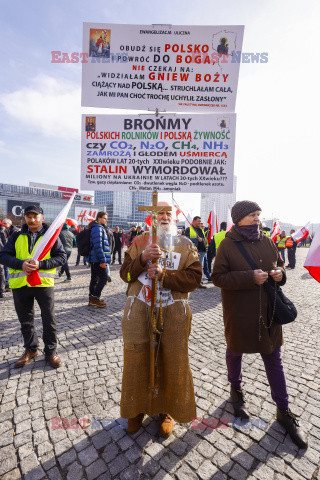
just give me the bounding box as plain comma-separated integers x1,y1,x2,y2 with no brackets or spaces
211,200,307,448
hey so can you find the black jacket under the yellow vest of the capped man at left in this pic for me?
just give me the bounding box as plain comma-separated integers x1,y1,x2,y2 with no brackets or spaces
0,223,67,270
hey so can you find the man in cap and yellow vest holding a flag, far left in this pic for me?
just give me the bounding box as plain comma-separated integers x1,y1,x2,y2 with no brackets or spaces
0,205,67,368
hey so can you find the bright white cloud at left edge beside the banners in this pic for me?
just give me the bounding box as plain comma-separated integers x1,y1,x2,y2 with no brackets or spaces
0,75,81,141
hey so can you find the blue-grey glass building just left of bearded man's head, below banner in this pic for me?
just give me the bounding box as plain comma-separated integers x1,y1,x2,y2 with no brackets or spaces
94,191,152,229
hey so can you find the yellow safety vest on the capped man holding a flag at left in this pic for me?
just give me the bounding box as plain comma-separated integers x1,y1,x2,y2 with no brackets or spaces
9,235,56,288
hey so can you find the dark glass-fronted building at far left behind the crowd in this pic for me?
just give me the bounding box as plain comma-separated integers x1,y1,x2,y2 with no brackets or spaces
0,183,105,226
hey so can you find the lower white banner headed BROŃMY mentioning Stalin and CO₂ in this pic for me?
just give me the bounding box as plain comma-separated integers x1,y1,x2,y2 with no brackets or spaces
80,113,236,193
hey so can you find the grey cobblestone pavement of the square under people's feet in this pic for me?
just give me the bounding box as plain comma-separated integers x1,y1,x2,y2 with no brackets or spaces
0,248,320,480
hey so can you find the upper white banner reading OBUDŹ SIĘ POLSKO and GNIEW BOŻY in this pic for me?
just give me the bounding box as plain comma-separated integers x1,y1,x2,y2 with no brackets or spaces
82,23,244,112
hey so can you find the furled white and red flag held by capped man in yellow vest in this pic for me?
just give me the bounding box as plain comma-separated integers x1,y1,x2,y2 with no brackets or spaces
27,192,75,287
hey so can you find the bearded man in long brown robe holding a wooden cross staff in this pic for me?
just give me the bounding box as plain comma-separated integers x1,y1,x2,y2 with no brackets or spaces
120,202,202,437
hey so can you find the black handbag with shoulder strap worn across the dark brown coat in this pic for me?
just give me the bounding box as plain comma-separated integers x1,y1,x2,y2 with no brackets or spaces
234,241,298,325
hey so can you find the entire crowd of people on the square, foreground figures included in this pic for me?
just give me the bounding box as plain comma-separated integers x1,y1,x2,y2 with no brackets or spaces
0,201,307,448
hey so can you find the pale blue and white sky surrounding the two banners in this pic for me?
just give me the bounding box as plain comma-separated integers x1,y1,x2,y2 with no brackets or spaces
0,0,320,224
